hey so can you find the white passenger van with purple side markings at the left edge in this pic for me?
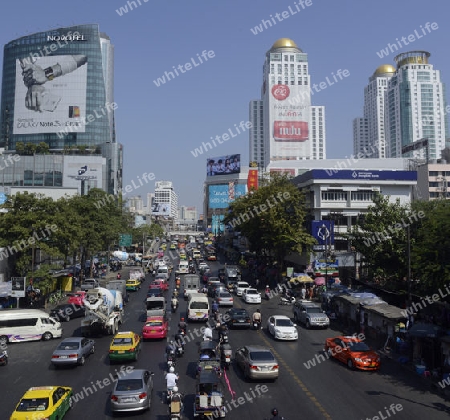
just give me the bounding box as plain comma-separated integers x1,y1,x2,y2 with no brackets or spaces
0,309,62,346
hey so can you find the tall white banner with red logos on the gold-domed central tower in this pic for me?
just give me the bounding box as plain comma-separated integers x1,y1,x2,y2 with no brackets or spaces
265,84,311,160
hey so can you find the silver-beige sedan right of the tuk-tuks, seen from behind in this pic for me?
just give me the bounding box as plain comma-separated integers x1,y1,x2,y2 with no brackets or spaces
234,345,279,381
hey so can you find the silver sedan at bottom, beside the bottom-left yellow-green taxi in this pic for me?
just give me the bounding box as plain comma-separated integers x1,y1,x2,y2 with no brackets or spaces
110,369,154,412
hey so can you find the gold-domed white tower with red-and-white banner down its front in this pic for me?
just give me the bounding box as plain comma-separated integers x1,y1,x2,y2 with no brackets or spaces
249,38,326,168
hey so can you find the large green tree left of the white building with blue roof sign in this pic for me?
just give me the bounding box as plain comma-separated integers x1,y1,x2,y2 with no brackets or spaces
224,174,315,269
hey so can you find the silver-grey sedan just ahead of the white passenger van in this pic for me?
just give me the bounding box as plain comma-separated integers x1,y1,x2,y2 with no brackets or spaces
51,337,95,368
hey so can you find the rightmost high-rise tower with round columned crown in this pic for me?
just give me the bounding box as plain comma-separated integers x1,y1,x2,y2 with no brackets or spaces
385,51,448,159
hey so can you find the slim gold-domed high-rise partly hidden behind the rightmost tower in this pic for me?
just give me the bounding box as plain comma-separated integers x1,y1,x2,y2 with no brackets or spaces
353,64,395,159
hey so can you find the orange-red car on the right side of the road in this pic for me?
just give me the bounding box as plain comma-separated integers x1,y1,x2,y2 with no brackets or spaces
325,336,380,370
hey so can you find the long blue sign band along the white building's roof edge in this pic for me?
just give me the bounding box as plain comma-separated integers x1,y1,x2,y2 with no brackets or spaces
296,168,417,183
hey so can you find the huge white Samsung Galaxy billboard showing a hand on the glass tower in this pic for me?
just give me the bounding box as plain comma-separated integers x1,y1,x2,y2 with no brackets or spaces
13,55,88,134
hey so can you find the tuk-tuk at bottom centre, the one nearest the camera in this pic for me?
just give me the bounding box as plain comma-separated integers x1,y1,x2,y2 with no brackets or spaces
194,371,226,418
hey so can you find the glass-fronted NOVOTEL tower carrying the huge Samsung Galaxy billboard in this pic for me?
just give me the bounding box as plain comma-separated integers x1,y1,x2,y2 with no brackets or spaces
0,24,123,194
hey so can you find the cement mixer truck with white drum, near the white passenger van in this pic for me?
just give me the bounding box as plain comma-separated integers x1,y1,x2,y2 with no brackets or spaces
81,287,123,337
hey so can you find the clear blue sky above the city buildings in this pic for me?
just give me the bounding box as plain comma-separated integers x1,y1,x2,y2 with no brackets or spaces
0,0,450,212
